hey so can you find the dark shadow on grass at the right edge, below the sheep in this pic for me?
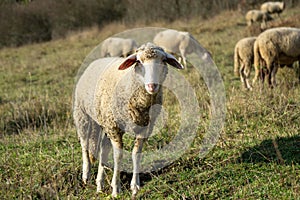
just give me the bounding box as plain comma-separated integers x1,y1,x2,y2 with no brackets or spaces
240,135,300,165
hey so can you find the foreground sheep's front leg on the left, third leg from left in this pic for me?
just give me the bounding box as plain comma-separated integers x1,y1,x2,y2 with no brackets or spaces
111,140,123,197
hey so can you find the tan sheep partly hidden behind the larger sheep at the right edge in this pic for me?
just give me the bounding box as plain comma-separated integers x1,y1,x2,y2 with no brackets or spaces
234,37,256,90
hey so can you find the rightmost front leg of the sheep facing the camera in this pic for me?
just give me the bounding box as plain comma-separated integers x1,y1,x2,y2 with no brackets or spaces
130,138,144,196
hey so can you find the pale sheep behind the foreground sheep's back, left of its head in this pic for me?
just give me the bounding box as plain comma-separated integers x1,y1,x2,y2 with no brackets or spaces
101,37,137,57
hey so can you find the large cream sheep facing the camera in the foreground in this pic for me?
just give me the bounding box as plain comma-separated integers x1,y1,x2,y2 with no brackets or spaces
73,43,183,197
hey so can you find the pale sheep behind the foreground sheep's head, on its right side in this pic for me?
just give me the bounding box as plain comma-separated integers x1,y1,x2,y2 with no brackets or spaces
153,30,196,67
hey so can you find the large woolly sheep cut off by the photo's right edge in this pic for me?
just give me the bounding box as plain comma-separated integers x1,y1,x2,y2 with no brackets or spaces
253,27,300,87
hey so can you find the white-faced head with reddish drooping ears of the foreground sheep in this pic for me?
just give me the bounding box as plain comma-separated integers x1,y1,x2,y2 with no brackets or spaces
119,43,183,94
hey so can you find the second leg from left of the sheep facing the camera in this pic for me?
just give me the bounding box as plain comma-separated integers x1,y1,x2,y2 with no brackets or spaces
96,133,111,192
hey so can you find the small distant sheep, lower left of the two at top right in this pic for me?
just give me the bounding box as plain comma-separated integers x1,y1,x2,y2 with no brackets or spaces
245,10,273,27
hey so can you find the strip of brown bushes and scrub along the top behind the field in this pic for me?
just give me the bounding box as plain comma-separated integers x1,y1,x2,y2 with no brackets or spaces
0,0,299,48
